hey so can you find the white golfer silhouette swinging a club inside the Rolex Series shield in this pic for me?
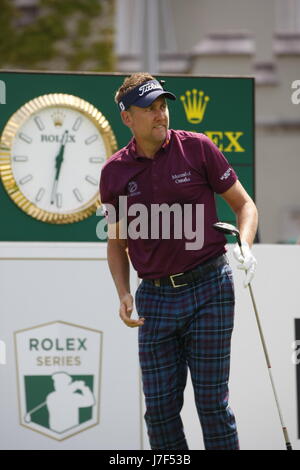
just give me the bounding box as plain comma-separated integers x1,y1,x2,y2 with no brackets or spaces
25,372,96,433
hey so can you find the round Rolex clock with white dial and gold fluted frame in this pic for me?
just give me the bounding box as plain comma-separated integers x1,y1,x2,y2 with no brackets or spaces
0,93,117,224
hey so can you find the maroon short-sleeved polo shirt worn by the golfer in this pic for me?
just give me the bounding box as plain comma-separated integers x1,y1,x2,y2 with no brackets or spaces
100,130,237,279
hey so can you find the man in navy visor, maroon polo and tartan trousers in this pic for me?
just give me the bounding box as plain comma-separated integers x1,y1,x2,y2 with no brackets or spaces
100,73,257,450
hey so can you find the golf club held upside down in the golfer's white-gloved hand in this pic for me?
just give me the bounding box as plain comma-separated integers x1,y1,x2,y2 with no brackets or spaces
213,222,293,450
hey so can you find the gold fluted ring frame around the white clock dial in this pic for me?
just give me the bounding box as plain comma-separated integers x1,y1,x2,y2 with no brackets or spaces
0,93,117,224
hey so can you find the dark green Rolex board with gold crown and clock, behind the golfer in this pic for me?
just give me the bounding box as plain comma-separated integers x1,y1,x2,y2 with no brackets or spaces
0,71,255,242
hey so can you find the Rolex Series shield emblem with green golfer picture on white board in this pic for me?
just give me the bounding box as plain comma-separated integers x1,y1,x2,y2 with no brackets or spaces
16,320,103,441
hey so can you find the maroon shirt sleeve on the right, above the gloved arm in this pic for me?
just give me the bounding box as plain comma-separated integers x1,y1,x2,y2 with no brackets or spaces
201,134,238,194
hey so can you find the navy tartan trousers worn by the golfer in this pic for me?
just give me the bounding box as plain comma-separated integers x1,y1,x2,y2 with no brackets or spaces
135,261,239,450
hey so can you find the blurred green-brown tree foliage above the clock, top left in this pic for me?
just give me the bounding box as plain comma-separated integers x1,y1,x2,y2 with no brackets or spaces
0,0,114,71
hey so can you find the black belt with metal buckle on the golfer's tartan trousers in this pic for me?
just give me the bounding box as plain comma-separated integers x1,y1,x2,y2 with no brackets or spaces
145,255,228,287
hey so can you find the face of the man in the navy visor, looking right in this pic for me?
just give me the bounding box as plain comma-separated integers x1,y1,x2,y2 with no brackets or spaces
123,97,169,143
